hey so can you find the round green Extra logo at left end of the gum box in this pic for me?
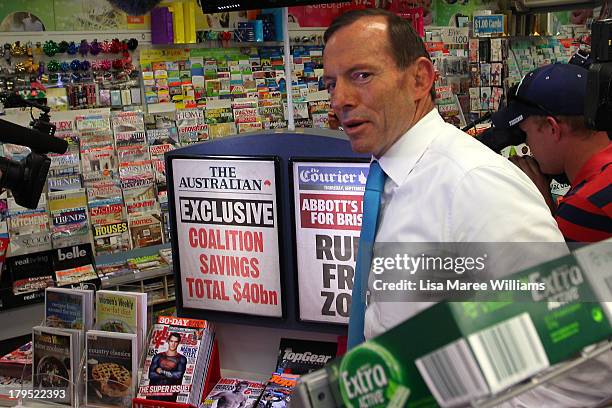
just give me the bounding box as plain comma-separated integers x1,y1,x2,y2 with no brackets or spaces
339,341,410,408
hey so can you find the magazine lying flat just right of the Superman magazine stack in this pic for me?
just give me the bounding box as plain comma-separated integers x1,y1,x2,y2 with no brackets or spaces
199,378,265,408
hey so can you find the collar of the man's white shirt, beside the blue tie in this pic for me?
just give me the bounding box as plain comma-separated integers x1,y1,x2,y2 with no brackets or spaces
378,108,444,185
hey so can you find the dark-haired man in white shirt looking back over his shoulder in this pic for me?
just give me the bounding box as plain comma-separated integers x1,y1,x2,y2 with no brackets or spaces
323,9,608,406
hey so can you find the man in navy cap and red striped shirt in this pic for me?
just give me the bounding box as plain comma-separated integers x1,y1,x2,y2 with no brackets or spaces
493,64,612,242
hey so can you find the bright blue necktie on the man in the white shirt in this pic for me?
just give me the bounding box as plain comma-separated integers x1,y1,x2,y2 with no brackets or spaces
347,161,387,350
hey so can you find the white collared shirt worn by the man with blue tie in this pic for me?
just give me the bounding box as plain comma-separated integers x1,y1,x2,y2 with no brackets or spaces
364,109,567,339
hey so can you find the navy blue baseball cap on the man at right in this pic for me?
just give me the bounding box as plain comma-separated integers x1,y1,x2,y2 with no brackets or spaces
492,64,588,129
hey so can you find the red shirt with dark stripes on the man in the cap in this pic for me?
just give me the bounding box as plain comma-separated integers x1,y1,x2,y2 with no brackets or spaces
555,143,612,242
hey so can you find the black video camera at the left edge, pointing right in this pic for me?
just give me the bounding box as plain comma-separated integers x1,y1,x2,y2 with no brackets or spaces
0,95,68,208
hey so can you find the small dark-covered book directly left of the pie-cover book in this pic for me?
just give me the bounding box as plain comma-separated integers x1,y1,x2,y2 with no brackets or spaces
32,326,80,406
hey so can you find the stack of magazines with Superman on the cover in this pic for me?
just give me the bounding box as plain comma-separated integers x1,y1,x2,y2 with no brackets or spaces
138,316,214,406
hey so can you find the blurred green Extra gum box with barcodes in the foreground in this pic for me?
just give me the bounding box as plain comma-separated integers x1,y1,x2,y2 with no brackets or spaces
326,241,612,408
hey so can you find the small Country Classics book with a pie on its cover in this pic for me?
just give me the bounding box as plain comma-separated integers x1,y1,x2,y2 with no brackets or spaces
85,330,138,407
